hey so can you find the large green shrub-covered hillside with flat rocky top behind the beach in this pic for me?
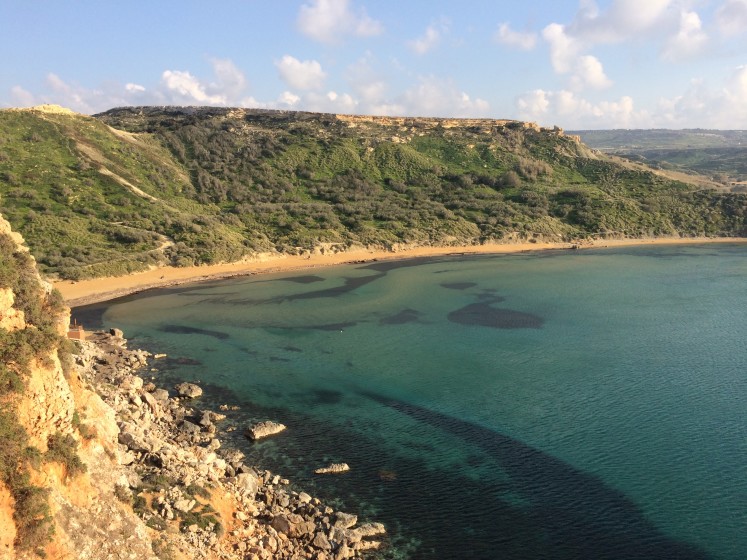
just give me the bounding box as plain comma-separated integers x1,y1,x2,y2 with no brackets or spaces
0,106,747,279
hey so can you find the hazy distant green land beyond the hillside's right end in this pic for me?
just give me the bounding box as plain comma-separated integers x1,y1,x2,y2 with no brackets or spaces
573,129,747,186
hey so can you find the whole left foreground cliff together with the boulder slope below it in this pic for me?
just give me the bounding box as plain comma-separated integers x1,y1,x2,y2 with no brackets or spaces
0,212,385,560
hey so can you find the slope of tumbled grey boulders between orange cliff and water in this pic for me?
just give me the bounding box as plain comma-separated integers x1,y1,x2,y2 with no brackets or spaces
76,329,385,560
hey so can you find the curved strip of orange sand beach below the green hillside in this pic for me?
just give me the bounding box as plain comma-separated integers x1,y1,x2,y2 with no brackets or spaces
53,237,747,307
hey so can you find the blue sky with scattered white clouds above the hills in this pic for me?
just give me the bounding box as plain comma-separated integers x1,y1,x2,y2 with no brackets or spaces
0,0,747,130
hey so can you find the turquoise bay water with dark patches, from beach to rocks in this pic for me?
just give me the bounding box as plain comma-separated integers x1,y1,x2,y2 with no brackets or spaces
76,245,747,559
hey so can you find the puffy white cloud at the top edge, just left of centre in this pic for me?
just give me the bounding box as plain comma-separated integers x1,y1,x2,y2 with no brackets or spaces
298,0,384,44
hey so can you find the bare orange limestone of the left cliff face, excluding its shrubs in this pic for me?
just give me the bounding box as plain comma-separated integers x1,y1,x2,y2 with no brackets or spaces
0,217,155,560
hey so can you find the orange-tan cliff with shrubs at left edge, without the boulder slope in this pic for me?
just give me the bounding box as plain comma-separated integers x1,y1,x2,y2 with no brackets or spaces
0,217,154,559
